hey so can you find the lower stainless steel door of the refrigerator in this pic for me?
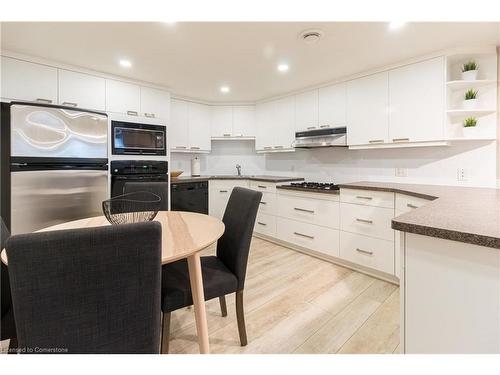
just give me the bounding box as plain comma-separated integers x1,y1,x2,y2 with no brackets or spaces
11,170,108,234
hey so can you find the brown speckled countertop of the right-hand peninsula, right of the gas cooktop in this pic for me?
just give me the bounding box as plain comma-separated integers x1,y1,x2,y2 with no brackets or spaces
340,181,500,249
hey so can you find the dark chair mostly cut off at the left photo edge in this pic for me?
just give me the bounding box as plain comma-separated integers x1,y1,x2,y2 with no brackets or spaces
0,218,17,348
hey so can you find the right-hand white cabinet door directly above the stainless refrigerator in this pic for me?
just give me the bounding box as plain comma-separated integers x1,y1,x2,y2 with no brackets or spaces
59,69,106,111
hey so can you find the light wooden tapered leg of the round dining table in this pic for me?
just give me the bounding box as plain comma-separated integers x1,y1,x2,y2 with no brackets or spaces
187,253,210,354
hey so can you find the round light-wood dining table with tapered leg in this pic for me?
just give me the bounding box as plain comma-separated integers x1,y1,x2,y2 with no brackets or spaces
1,211,225,354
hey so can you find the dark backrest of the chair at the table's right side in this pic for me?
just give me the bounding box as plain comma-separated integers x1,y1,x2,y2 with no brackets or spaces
217,187,262,290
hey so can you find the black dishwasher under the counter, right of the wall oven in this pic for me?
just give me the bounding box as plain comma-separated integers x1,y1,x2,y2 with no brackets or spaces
170,181,208,215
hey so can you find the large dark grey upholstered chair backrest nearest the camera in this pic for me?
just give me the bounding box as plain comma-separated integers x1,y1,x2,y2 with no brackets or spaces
6,222,161,353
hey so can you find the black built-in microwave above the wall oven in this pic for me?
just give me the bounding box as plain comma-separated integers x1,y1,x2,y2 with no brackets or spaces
111,121,167,155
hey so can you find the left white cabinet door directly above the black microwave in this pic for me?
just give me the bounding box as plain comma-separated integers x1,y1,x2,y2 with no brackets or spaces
106,79,141,116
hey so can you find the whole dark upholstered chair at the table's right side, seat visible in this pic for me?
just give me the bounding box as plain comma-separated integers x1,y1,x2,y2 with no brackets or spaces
161,187,262,353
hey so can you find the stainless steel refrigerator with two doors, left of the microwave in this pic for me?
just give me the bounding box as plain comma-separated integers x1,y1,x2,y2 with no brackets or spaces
4,103,108,234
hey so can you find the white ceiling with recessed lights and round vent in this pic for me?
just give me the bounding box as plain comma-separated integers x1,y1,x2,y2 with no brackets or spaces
1,22,500,102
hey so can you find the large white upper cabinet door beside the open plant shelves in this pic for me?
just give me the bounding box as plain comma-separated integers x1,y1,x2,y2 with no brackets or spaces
389,57,445,142
